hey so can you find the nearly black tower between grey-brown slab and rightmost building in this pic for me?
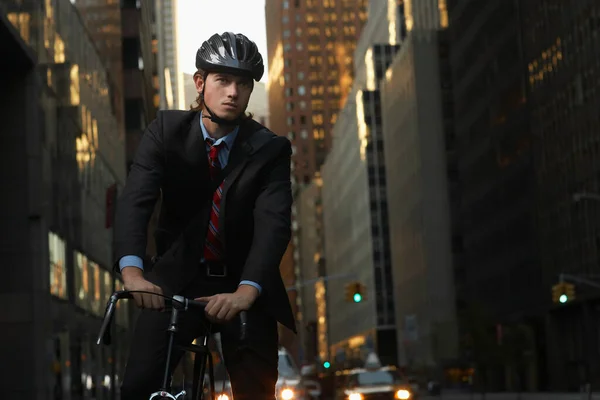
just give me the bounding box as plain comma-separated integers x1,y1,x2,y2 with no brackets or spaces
449,0,540,390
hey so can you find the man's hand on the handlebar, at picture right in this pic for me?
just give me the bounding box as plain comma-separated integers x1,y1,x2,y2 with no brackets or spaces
196,285,258,323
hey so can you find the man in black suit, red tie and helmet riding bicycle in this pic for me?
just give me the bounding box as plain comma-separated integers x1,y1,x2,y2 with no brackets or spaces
115,32,295,400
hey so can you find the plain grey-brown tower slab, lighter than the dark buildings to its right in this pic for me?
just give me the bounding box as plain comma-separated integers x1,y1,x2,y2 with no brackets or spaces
381,18,460,378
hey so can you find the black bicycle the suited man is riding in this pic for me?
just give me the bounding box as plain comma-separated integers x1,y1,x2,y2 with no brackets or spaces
96,290,247,400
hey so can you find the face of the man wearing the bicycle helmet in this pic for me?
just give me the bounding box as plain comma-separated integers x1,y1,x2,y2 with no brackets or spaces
195,73,254,119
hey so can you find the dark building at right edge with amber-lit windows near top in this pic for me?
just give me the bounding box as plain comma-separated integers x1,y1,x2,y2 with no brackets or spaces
520,0,600,391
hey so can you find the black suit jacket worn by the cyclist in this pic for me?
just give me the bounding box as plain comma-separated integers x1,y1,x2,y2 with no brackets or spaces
115,111,295,331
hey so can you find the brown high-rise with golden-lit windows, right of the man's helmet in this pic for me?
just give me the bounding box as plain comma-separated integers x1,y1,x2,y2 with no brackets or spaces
265,0,367,360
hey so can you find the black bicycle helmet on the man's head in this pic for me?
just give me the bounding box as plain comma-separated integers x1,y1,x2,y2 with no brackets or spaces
196,32,265,82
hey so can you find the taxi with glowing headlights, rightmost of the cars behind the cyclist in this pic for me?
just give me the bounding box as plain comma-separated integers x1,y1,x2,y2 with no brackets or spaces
335,359,416,400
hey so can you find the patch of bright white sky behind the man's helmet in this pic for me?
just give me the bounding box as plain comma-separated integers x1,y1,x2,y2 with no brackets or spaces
177,0,268,82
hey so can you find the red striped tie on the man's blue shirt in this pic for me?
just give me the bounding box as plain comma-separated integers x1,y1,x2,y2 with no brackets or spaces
204,139,223,261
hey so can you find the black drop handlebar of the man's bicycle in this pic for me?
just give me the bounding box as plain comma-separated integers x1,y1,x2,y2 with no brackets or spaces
96,290,247,345
